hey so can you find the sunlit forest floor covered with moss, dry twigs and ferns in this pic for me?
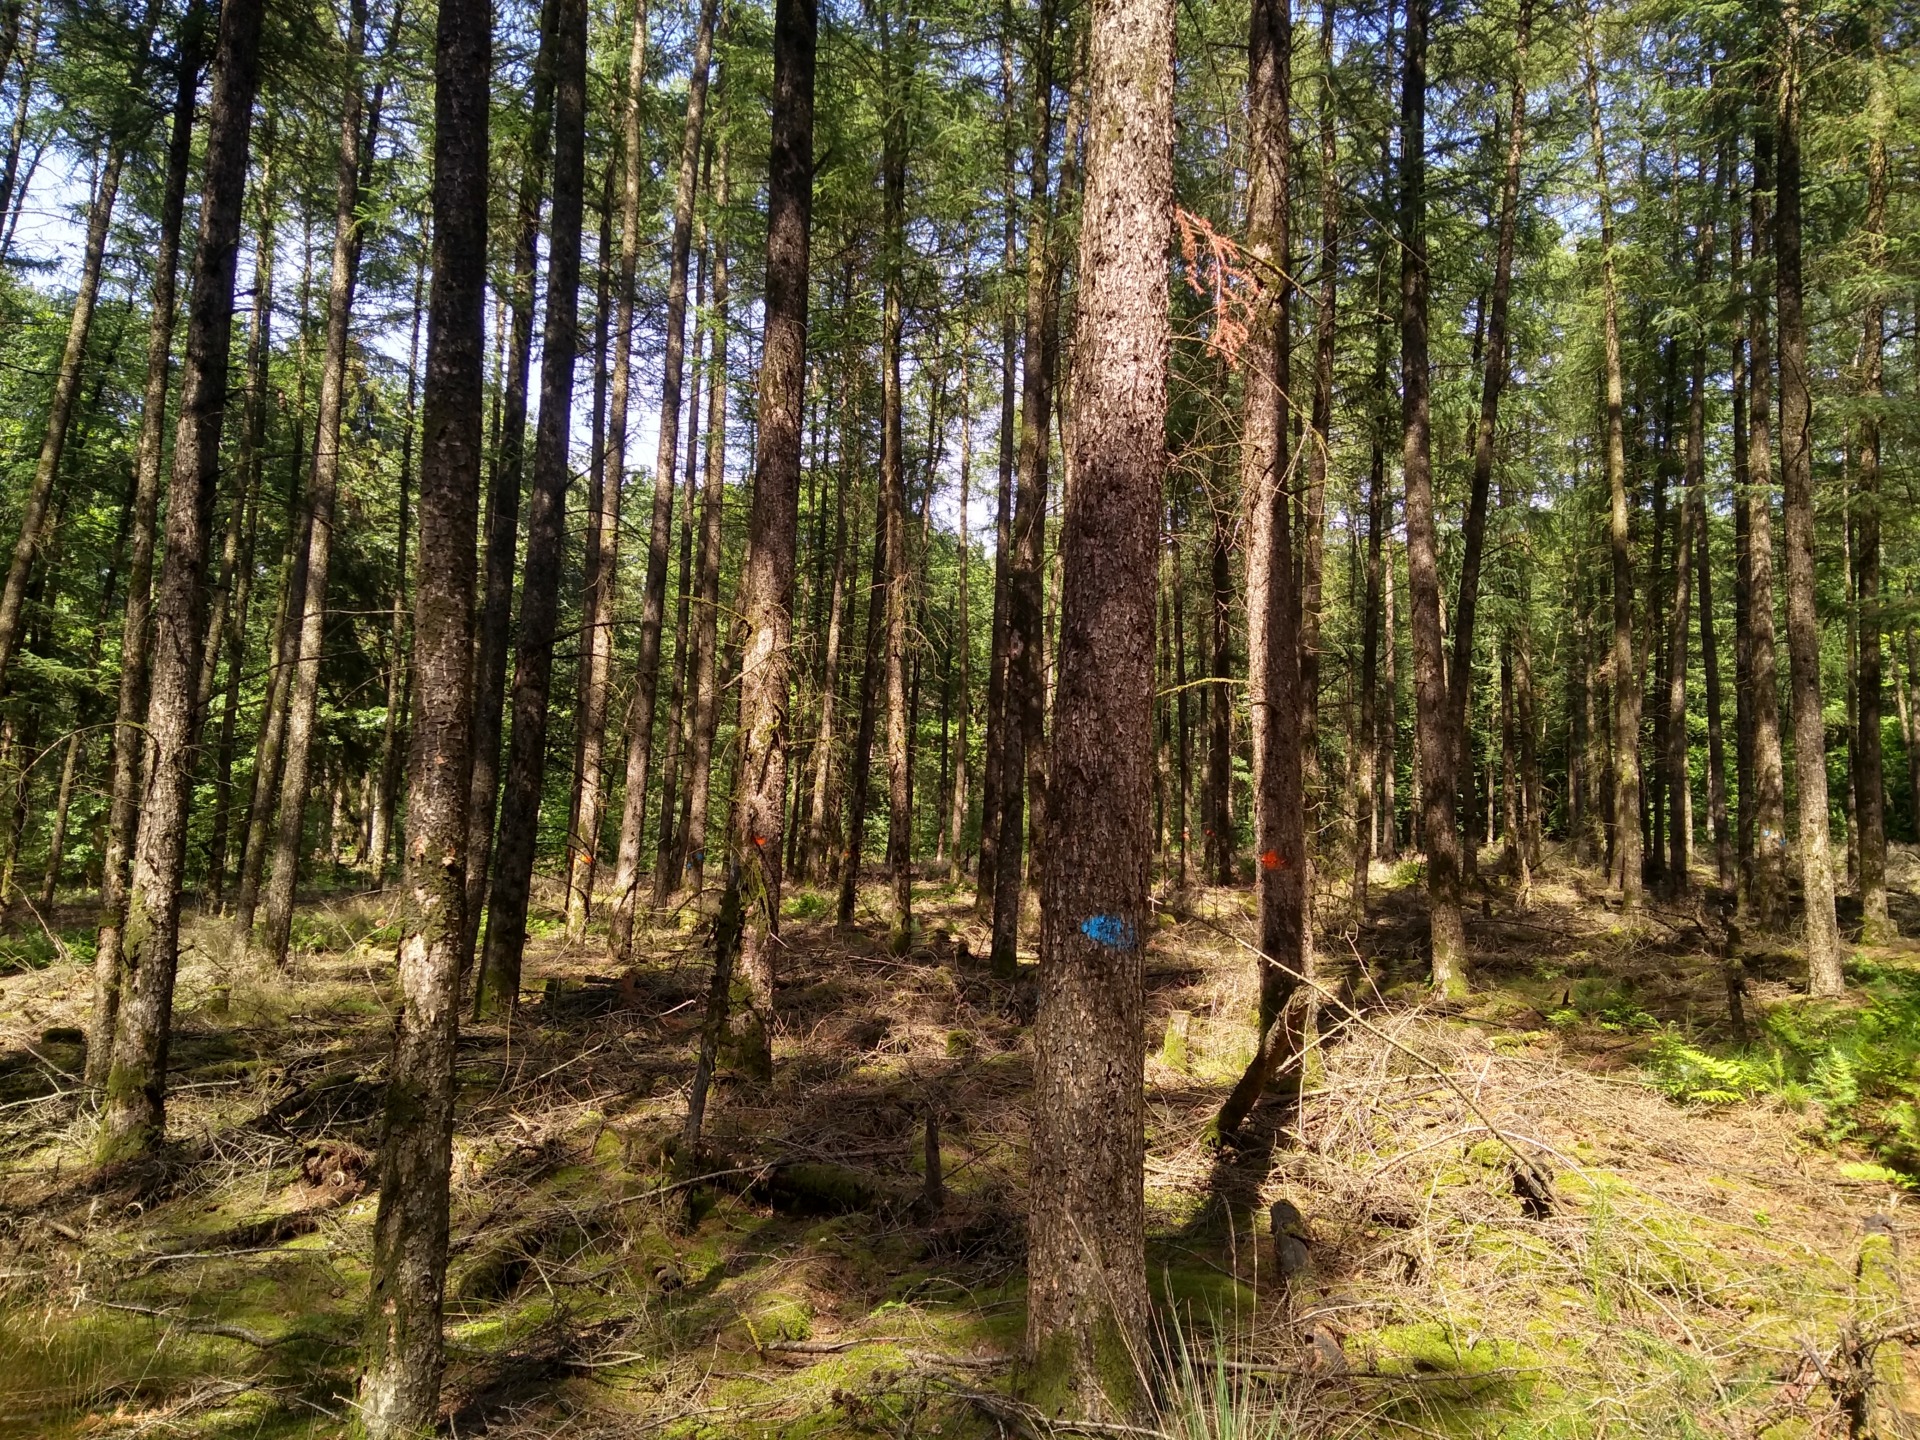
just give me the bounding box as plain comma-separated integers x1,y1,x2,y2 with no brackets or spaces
0,852,1920,1440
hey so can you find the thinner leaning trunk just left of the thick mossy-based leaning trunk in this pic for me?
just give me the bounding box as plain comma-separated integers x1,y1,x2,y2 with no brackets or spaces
87,19,202,1087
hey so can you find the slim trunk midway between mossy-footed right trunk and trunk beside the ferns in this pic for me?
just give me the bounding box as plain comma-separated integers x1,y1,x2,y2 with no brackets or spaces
1584,33,1642,910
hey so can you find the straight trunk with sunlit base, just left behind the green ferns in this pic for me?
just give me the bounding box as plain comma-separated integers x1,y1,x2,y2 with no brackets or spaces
1774,0,1847,995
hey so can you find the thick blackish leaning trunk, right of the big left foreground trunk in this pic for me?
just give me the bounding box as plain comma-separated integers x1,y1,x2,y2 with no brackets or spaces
474,0,588,1016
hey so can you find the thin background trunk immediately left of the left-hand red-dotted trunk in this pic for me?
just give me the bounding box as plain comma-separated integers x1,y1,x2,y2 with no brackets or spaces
676,132,732,895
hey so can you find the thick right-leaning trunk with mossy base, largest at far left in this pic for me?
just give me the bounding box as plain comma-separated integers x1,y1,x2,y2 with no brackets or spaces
100,0,265,1160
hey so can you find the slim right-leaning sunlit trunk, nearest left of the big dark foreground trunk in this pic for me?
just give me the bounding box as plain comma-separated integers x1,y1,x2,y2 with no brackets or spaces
265,0,384,966
